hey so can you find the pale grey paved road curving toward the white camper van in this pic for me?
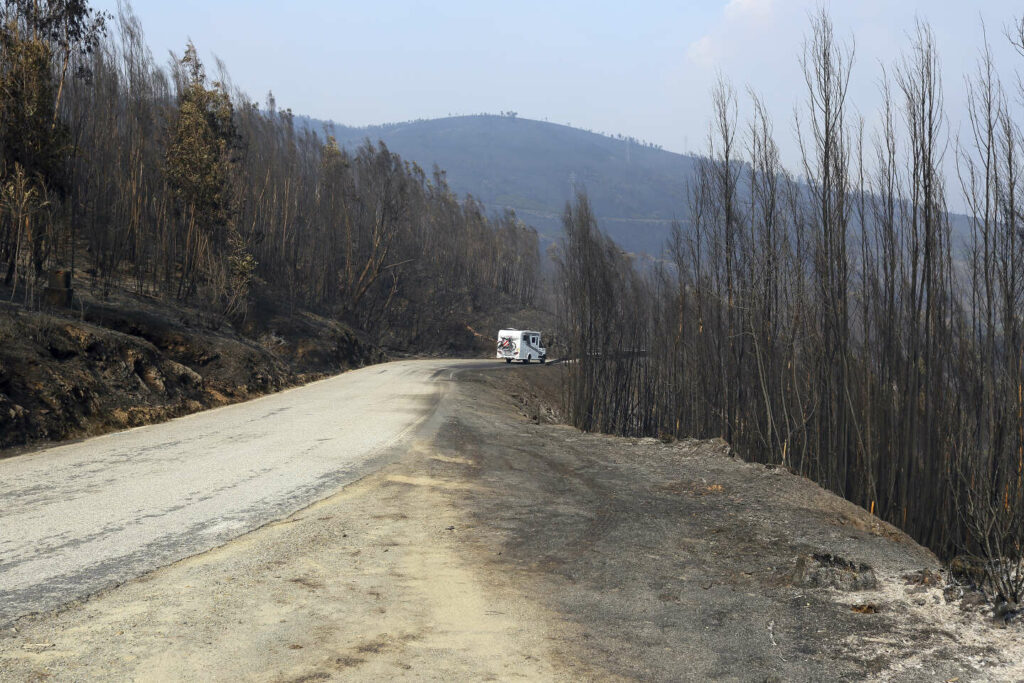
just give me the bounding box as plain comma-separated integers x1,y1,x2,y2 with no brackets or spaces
0,360,494,625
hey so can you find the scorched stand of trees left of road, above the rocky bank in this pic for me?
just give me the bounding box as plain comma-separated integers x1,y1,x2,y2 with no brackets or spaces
0,0,540,349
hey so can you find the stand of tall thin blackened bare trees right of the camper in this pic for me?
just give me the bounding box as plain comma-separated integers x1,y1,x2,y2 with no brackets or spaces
561,11,1024,605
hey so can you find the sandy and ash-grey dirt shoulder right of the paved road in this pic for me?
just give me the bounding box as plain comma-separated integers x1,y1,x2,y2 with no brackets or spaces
0,366,1024,681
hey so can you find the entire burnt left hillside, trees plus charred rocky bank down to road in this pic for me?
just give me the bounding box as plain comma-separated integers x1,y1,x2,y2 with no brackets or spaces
0,0,540,446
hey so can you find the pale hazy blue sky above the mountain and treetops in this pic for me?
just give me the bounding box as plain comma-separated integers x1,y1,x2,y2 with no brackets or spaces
94,0,1024,171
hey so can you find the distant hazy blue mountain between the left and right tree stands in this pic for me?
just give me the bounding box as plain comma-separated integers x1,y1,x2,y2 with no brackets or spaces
315,115,696,255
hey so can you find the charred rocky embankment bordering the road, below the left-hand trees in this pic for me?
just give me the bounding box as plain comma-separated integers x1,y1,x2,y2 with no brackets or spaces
0,296,384,457
